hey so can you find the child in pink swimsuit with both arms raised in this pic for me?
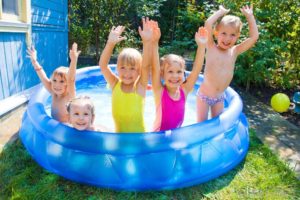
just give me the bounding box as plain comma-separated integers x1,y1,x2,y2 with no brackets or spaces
152,21,207,131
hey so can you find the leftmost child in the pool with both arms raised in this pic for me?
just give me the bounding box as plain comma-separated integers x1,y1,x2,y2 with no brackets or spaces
27,43,80,122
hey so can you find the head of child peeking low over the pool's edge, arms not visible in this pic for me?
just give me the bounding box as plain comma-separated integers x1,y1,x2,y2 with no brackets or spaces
68,99,95,131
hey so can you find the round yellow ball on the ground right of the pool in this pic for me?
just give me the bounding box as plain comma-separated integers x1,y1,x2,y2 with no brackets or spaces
271,93,291,113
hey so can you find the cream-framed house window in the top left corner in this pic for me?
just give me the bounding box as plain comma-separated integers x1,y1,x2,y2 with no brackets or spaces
0,0,31,44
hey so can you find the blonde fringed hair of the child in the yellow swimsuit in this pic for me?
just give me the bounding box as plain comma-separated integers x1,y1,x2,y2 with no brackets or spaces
117,48,142,70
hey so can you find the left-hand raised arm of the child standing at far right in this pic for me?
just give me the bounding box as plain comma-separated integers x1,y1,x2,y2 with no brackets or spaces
205,5,230,46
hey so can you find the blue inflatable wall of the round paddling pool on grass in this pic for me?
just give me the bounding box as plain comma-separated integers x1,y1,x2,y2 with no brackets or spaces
20,67,249,191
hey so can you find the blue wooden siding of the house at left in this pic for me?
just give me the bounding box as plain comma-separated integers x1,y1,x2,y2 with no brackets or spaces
0,0,68,101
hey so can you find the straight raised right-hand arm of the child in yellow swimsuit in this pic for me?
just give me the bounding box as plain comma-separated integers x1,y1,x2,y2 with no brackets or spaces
139,18,153,93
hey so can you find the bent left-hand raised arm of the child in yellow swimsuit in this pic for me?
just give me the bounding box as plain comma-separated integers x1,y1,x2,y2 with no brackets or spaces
99,26,126,88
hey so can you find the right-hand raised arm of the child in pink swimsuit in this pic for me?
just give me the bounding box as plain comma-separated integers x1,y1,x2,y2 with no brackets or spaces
183,27,208,94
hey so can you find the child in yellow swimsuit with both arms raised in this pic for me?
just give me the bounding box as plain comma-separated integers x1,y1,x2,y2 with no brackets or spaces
99,19,153,133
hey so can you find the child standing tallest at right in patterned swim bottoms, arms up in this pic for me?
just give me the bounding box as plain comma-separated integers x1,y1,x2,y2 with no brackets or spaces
197,6,258,122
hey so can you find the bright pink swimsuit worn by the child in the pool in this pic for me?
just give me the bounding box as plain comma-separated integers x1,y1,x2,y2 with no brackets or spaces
156,87,185,131
